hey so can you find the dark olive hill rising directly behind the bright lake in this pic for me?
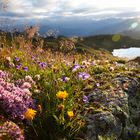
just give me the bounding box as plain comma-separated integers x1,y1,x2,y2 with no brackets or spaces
79,35,140,51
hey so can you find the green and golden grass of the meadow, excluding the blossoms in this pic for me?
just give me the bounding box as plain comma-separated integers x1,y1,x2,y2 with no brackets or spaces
0,32,140,140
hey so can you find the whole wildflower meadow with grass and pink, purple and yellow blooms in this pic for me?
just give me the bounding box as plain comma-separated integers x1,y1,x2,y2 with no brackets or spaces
0,32,140,140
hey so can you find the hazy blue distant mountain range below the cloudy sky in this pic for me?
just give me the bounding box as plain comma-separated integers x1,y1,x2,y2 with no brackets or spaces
0,18,140,39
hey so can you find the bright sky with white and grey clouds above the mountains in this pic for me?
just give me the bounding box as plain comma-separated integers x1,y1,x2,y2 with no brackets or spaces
0,0,140,20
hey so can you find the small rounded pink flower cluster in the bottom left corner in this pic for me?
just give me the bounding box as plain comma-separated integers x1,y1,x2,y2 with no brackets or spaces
0,121,24,140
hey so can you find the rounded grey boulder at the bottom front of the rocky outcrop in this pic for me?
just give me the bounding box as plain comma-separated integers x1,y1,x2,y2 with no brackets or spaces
87,112,122,140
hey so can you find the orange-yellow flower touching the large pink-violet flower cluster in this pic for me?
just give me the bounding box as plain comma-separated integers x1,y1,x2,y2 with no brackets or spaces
24,108,37,120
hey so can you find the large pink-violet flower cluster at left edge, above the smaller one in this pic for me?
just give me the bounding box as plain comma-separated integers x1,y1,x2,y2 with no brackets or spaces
0,71,35,119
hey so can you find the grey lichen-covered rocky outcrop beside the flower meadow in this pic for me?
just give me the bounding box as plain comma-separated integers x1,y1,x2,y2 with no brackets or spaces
84,77,140,140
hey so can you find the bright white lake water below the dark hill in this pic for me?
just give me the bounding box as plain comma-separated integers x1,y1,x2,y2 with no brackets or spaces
112,47,140,59
